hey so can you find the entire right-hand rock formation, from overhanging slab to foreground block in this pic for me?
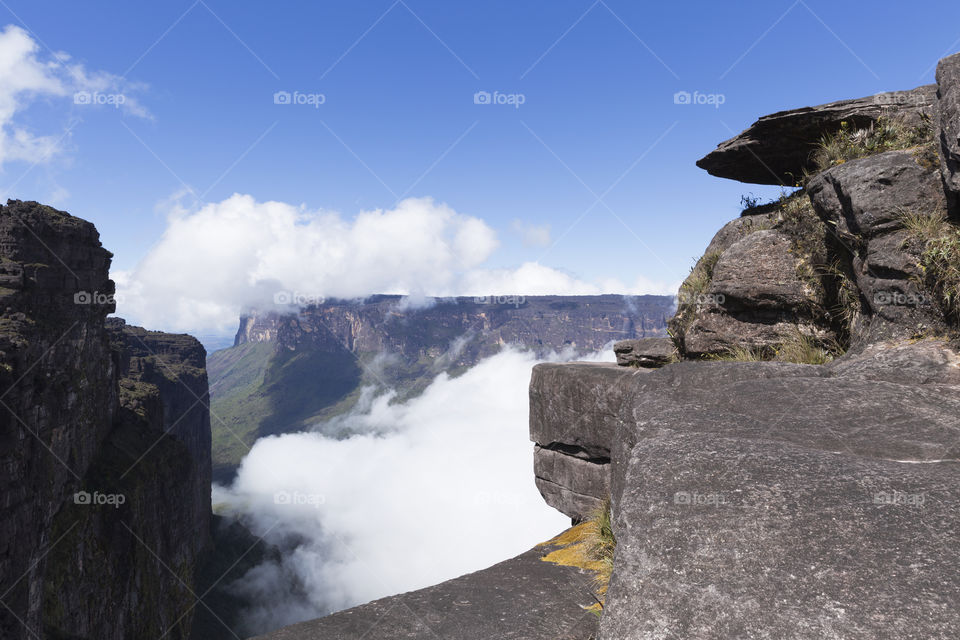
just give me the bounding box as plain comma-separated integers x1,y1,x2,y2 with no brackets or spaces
530,55,960,640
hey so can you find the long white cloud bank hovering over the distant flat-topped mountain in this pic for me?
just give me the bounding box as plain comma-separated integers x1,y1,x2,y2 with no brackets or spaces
112,194,676,333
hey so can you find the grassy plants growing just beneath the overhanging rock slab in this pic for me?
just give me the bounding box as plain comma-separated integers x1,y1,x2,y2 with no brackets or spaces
811,114,935,173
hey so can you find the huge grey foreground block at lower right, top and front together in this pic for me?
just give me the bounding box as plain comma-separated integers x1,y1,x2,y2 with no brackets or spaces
576,348,960,639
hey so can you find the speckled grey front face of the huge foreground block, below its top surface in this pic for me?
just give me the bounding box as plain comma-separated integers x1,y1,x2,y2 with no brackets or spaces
600,432,960,640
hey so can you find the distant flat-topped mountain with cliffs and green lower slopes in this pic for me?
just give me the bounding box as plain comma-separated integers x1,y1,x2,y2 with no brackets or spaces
207,295,674,481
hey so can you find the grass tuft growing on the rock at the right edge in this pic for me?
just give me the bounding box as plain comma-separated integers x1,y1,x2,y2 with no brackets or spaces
900,211,960,321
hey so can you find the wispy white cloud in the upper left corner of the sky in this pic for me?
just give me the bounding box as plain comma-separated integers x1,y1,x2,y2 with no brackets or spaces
0,25,150,166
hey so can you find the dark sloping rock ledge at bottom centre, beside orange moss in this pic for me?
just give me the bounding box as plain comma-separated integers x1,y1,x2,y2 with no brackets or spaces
258,536,598,640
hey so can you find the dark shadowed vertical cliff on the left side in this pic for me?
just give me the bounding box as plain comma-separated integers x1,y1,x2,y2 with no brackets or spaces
0,201,210,640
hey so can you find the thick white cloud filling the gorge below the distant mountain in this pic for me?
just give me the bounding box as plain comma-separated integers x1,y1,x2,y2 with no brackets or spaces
214,345,613,632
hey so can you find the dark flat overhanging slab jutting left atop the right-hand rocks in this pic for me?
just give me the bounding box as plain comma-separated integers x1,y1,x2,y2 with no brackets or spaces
697,84,936,186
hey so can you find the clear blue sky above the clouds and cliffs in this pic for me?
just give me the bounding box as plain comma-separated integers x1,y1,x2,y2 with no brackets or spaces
0,0,960,336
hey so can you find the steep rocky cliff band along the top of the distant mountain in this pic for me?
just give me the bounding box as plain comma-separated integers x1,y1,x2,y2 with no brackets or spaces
234,295,673,356
